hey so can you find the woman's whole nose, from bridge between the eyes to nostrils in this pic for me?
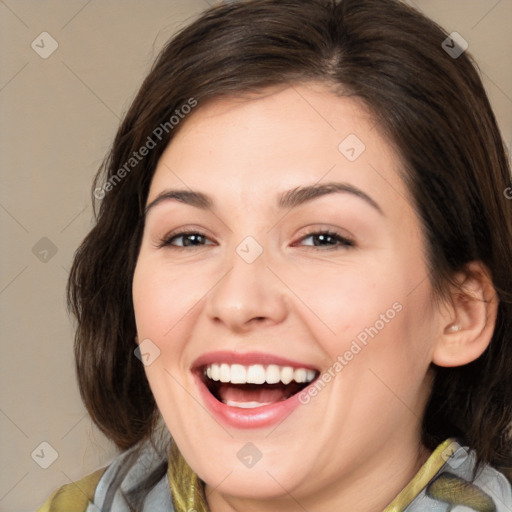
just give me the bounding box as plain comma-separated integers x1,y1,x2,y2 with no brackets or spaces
208,231,286,329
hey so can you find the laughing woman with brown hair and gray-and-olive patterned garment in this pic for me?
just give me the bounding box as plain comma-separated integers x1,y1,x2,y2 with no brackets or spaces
41,0,512,512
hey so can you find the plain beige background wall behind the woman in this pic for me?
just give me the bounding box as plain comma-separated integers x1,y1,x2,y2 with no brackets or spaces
0,0,512,512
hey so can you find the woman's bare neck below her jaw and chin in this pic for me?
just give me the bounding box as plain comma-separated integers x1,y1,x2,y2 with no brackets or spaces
205,440,431,512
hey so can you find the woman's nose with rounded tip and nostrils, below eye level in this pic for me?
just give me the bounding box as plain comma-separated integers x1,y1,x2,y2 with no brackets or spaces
205,239,289,333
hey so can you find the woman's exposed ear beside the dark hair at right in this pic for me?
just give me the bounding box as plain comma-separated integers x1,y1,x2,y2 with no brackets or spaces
432,262,498,366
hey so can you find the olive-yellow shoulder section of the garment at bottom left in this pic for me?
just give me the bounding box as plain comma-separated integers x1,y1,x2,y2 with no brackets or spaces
37,467,107,512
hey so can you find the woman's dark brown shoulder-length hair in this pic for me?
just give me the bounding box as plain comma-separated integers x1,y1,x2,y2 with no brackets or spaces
68,0,512,504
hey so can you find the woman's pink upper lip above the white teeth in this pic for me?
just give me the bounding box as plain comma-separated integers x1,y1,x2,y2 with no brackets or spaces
192,350,318,371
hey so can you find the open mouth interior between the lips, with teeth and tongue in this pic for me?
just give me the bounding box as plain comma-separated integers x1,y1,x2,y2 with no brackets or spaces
199,363,319,409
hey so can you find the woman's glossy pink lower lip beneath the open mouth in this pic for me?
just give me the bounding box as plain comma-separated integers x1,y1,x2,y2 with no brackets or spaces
194,374,302,429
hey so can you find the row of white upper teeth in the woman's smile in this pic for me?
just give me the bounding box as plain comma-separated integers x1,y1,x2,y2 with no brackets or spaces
205,363,316,384
